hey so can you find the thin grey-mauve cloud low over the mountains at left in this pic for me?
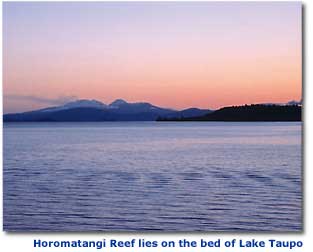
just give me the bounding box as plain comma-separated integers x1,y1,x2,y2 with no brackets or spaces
4,94,78,106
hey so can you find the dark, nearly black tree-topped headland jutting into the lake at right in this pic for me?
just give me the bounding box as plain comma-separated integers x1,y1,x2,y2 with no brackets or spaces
158,104,302,122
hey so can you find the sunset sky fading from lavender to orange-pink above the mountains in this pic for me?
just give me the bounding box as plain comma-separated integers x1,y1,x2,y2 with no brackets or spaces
3,2,302,113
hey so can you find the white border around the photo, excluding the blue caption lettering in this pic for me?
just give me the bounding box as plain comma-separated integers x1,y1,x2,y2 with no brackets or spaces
0,1,313,252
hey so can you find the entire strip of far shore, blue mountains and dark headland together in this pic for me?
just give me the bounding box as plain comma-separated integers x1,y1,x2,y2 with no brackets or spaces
3,100,302,122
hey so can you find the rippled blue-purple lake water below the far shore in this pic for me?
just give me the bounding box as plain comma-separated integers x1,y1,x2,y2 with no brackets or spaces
3,122,302,231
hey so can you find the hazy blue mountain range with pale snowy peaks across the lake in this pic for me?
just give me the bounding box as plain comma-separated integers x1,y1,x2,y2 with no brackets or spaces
3,99,210,122
